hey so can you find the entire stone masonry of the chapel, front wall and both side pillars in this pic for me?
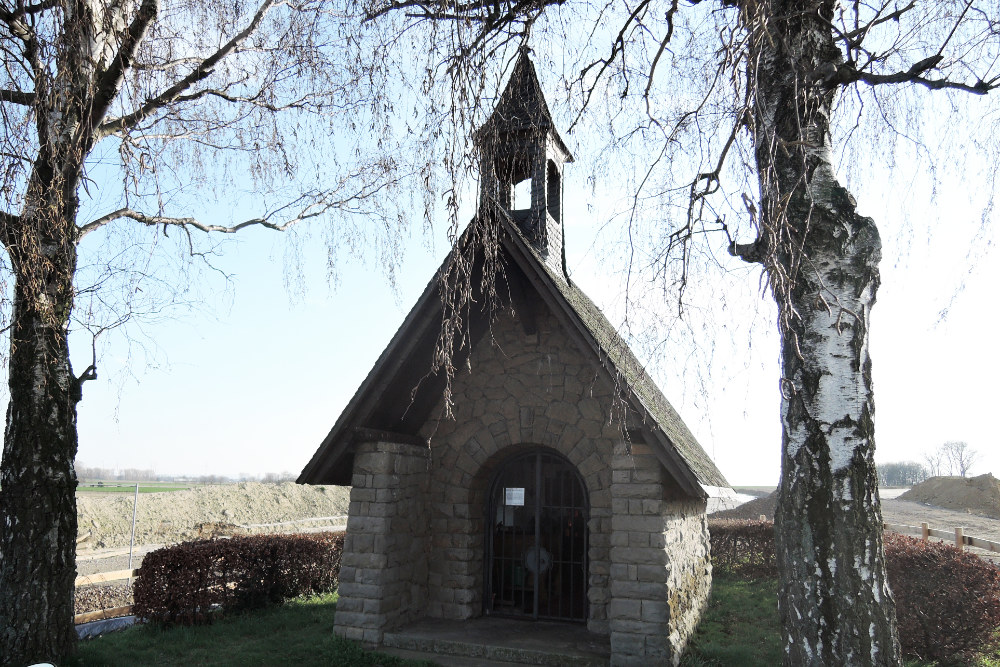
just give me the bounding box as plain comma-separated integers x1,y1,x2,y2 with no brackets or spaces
335,310,711,665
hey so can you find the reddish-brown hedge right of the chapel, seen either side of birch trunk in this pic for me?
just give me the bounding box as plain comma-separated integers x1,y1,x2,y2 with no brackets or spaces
708,520,1000,664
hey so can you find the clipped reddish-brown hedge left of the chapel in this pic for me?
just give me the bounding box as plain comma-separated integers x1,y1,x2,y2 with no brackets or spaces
133,533,344,625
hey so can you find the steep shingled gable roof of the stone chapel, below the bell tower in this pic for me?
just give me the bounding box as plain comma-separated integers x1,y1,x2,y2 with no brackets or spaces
298,207,729,497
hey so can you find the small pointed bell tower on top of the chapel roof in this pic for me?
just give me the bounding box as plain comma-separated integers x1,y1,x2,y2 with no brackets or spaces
475,48,573,274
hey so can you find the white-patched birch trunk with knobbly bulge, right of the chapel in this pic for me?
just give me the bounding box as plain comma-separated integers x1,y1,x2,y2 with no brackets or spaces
743,0,900,667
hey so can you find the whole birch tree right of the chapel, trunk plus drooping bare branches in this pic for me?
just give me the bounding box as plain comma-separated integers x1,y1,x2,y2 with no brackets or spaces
356,0,1000,667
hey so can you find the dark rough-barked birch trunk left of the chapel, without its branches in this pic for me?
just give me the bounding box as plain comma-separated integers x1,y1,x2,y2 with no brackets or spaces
0,2,94,665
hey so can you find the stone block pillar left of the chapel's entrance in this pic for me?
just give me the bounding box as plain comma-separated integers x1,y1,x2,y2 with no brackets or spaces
334,442,428,646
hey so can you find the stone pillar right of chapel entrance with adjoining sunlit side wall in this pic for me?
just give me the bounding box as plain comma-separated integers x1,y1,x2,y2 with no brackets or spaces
609,443,712,665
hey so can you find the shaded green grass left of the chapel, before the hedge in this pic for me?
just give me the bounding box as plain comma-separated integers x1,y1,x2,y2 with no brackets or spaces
66,593,432,667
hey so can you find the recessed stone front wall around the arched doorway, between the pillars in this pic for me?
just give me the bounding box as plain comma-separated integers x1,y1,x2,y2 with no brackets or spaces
427,313,621,633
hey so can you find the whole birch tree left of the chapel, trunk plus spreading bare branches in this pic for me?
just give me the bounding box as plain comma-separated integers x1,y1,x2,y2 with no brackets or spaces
0,0,400,665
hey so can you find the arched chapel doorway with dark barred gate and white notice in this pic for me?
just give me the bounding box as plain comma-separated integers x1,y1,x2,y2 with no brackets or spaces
483,448,590,621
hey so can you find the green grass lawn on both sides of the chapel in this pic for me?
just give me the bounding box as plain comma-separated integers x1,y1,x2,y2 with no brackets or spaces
66,574,1000,667
